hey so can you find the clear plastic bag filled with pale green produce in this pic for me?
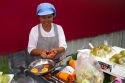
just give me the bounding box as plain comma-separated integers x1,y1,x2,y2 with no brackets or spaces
75,52,104,83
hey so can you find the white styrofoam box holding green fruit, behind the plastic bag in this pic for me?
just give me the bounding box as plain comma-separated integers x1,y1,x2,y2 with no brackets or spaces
77,46,125,79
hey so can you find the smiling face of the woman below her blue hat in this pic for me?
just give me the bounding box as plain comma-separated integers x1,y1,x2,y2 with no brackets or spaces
39,14,53,25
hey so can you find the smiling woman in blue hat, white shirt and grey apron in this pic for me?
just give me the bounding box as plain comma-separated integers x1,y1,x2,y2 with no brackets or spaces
28,3,67,59
